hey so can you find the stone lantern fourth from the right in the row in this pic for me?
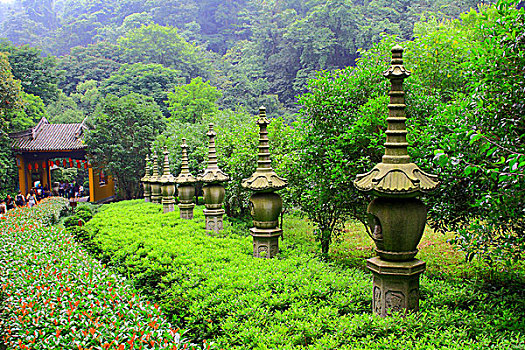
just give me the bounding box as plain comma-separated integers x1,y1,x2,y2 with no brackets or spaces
175,139,197,220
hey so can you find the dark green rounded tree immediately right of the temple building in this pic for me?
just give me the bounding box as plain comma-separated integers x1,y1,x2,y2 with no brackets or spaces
85,94,165,199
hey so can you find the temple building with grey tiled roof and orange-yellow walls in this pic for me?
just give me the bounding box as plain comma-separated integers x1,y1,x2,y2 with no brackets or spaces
9,118,115,202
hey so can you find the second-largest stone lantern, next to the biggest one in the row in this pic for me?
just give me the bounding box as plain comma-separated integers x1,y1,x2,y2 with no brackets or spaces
242,107,287,258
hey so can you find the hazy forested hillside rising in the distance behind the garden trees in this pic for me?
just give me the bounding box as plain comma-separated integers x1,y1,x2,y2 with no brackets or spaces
0,0,480,113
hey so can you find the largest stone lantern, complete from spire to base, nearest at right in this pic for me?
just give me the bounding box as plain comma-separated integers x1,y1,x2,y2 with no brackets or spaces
354,45,439,317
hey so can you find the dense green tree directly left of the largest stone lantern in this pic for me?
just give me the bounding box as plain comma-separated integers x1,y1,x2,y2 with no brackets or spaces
290,40,393,256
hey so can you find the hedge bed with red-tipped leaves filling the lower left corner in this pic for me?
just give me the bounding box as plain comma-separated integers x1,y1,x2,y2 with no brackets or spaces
0,198,209,350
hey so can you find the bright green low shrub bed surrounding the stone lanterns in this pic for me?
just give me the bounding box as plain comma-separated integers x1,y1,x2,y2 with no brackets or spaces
83,200,525,349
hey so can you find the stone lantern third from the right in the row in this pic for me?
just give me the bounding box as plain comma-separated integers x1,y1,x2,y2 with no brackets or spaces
197,124,230,233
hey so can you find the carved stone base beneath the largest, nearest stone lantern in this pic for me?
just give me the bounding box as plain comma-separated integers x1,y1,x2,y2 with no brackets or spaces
366,257,426,317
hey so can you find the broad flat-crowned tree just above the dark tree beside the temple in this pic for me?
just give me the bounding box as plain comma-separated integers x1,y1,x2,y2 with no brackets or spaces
101,63,183,117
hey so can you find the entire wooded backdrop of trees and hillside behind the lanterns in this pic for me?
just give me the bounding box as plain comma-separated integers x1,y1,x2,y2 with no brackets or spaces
0,0,525,259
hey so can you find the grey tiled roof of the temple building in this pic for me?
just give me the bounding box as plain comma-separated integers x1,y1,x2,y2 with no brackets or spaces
9,118,86,151
